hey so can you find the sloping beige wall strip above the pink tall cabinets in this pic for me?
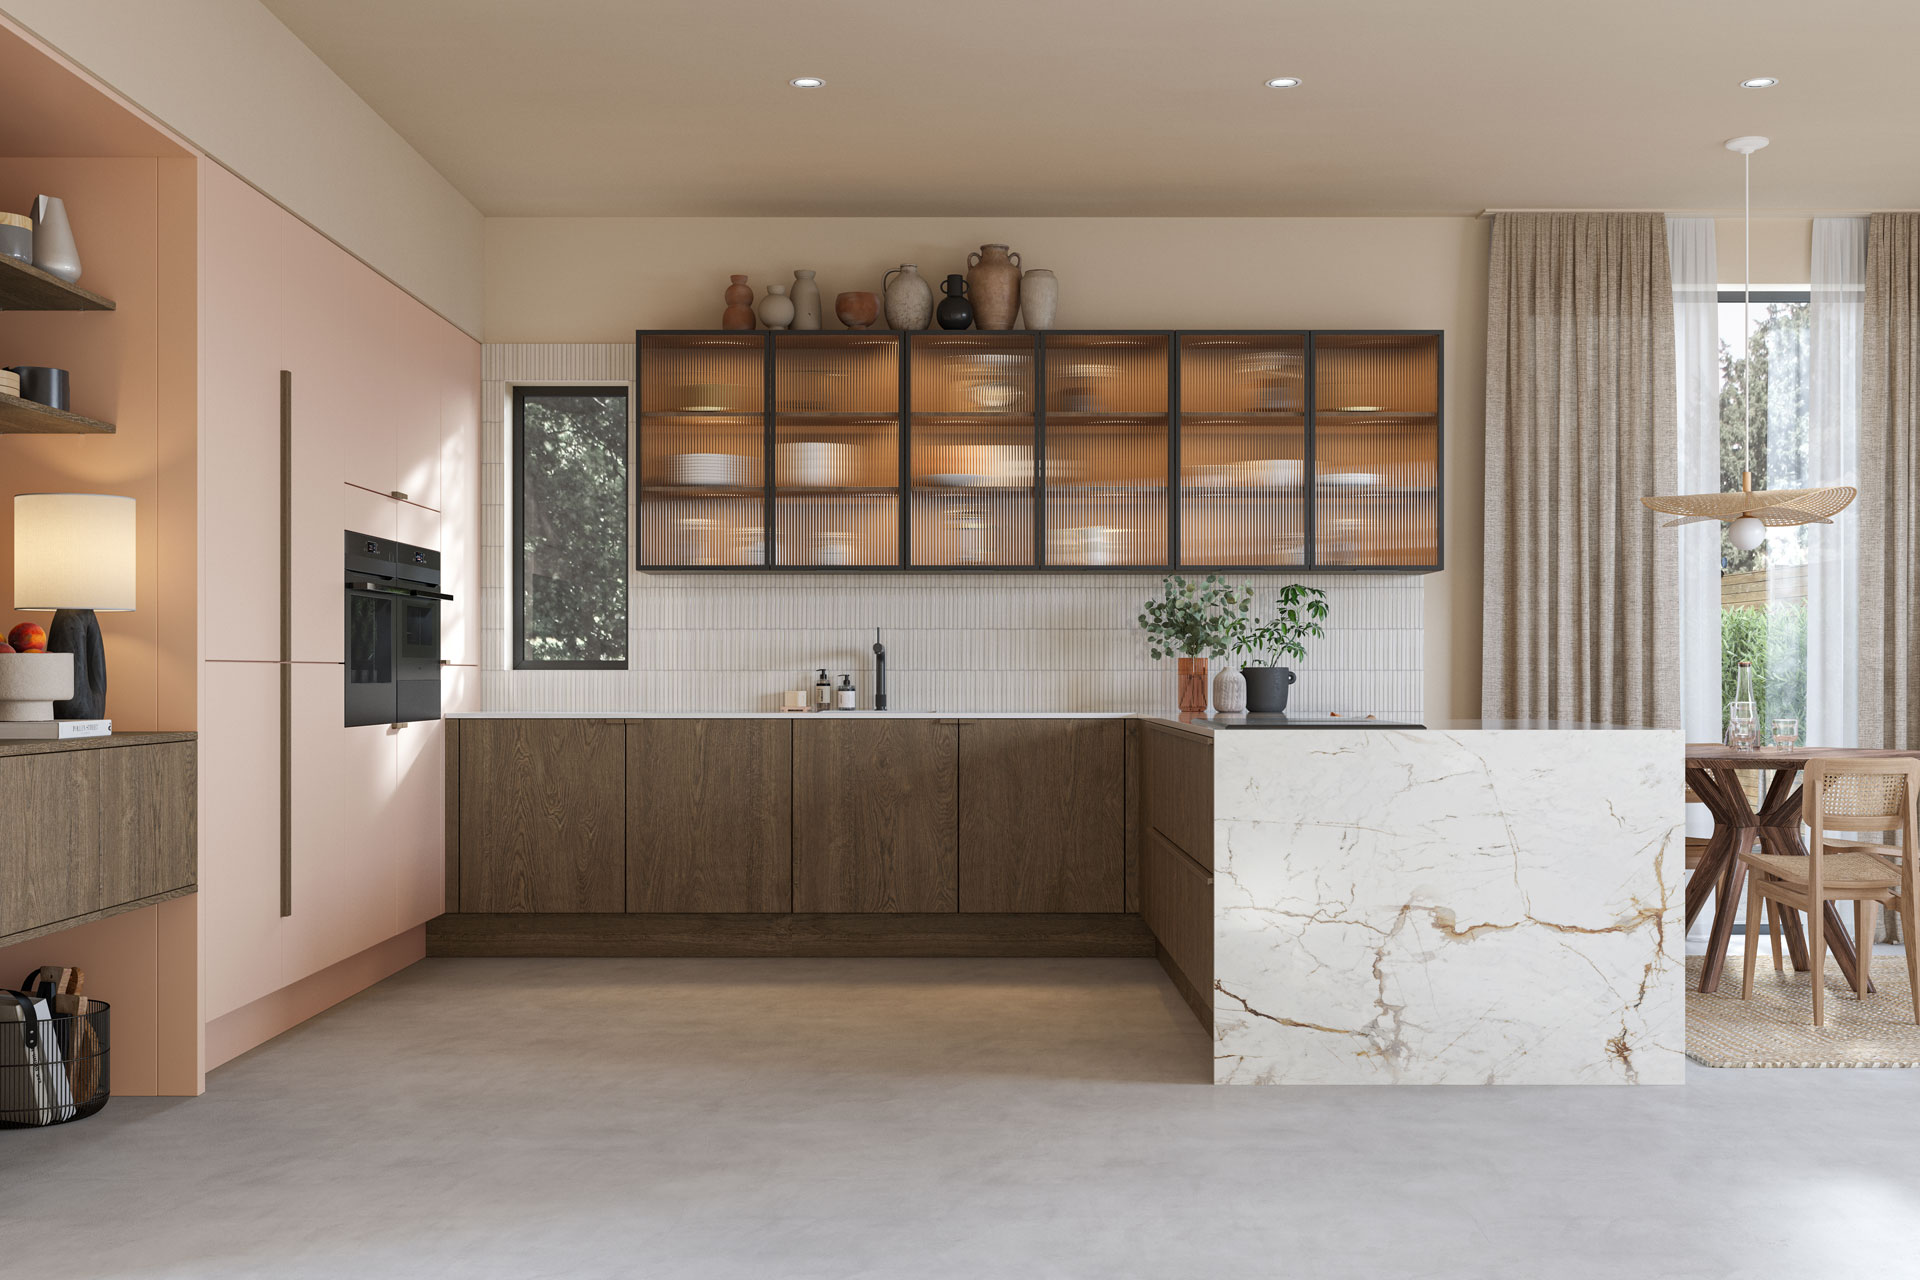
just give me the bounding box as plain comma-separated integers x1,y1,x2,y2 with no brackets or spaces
0,0,482,336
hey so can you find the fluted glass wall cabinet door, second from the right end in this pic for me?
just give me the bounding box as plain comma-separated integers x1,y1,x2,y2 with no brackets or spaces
1181,334,1308,566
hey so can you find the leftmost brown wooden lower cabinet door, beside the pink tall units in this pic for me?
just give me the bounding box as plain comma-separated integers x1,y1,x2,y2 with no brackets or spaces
461,718,626,912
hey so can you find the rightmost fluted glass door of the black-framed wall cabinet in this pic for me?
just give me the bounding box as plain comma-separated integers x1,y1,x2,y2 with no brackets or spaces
1313,332,1440,568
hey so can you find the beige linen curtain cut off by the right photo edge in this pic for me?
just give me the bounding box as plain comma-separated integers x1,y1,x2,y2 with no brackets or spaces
1859,213,1920,750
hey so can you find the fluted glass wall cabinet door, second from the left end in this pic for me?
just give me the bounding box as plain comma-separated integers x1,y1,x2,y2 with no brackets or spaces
774,332,900,568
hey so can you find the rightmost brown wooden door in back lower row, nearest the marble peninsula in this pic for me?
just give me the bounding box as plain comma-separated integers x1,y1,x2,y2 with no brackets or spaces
960,720,1127,912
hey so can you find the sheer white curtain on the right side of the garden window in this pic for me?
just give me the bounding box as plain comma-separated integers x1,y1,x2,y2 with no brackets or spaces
1804,217,1866,747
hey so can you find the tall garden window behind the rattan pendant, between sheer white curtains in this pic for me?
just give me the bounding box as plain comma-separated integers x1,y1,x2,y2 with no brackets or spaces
1720,290,1811,735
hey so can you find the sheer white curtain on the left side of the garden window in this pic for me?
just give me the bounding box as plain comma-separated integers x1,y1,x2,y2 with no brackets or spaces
1651,217,1720,771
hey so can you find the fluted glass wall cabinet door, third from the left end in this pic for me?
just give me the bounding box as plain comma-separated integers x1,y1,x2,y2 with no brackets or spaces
906,332,1039,568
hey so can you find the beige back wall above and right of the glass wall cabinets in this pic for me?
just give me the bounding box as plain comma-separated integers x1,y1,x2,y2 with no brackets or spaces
484,217,1488,718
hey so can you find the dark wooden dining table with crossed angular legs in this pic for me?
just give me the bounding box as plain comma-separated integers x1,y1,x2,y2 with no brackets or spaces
1686,743,1920,992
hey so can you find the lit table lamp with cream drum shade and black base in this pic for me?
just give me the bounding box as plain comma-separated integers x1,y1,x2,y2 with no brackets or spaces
13,493,134,720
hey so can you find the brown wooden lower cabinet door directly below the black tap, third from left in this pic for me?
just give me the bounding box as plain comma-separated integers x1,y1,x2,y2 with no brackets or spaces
793,718,960,912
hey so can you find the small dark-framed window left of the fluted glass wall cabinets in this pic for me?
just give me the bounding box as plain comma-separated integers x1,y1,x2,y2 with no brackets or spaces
513,386,628,668
